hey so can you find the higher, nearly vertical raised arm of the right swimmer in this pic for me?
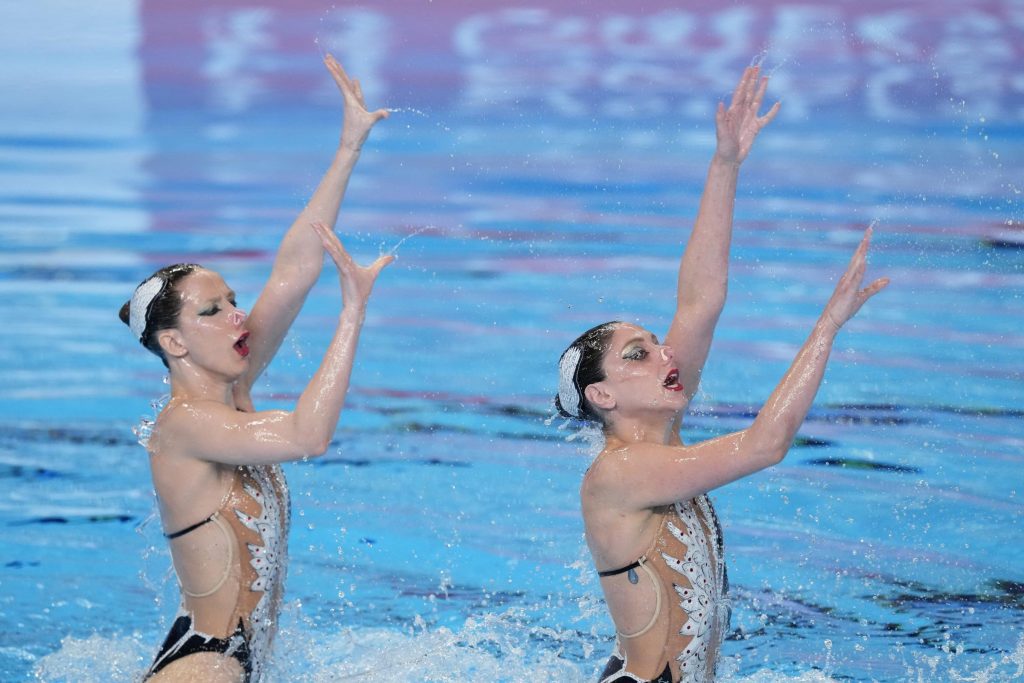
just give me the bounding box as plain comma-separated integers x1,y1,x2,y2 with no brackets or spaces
665,67,779,397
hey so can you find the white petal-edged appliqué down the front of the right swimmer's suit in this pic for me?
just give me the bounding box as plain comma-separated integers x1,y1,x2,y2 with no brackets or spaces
662,496,728,681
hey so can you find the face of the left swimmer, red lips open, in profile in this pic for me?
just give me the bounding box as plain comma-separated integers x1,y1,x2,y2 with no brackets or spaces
164,268,249,380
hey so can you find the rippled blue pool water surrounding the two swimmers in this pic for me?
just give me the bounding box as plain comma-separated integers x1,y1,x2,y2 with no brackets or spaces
0,0,1024,682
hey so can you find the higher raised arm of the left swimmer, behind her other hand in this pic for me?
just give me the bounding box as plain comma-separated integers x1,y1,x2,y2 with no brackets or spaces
236,54,387,397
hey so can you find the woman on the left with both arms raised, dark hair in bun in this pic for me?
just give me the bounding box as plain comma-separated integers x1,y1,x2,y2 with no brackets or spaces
121,55,391,682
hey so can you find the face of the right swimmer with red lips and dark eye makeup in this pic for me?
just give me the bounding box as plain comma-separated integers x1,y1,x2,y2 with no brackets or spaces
588,323,687,417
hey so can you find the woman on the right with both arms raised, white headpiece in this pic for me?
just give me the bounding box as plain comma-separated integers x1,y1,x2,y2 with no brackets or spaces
555,69,888,683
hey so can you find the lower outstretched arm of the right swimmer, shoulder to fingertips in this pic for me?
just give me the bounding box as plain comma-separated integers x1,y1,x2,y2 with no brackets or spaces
595,228,889,510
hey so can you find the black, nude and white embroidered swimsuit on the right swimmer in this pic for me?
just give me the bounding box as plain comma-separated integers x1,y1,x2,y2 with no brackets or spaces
601,496,730,683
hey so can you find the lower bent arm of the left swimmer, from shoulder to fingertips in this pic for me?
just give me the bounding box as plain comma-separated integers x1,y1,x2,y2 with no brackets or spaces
154,223,394,465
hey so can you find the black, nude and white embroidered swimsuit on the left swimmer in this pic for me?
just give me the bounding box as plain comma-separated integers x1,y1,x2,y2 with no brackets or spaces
148,465,290,683
